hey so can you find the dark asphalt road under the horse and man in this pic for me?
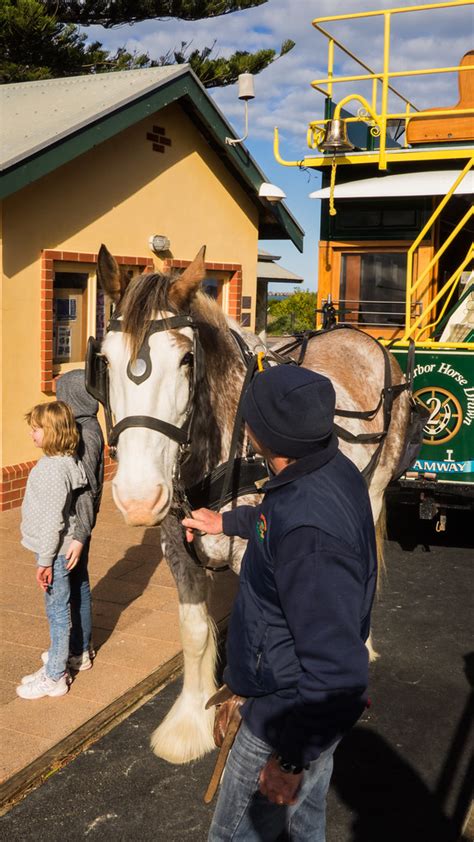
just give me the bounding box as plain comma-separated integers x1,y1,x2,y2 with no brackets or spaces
0,512,474,842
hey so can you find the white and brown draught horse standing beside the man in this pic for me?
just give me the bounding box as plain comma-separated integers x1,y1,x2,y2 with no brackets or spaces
94,246,409,763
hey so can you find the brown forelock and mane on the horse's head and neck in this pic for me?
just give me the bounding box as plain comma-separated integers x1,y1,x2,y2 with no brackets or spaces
116,273,243,486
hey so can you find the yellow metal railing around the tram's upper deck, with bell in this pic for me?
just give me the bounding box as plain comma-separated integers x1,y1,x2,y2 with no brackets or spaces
274,0,474,170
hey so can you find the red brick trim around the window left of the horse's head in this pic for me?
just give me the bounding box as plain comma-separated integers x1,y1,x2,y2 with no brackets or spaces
40,249,154,393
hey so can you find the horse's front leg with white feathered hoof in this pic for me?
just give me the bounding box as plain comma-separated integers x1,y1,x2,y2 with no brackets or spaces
151,519,216,763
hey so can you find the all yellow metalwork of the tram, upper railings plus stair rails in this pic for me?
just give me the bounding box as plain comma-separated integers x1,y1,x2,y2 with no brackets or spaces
273,0,474,350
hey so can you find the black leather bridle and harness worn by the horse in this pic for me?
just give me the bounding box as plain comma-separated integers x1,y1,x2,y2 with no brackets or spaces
85,314,413,572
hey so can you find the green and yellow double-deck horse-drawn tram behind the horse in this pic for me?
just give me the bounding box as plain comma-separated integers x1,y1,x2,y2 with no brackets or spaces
274,0,474,531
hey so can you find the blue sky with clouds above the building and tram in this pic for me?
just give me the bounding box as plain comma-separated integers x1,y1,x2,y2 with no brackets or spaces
83,0,473,290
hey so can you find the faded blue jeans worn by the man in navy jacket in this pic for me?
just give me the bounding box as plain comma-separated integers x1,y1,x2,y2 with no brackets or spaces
209,722,337,842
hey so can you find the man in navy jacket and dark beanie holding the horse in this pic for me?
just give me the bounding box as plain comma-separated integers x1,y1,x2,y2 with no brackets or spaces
183,366,377,842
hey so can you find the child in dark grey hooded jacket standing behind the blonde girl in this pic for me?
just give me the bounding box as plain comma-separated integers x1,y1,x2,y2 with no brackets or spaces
56,369,104,670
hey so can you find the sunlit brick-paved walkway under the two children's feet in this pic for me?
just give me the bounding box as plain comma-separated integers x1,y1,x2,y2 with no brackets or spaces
0,483,237,801
